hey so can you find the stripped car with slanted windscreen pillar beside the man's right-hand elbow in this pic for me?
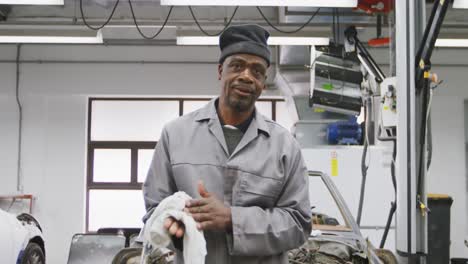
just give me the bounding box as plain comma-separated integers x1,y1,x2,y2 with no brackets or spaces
289,171,397,264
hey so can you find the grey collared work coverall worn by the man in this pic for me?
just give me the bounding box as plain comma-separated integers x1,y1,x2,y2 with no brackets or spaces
143,99,311,264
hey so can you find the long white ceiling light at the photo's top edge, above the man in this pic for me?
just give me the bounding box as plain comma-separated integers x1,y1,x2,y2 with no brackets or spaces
161,0,357,7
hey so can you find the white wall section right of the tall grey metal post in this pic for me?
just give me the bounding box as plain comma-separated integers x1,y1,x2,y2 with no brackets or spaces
427,63,468,258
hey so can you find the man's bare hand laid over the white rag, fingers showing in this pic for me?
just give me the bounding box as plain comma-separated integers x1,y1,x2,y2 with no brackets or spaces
186,182,232,230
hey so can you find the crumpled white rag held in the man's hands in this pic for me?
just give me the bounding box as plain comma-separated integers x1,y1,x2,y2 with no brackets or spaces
144,192,206,264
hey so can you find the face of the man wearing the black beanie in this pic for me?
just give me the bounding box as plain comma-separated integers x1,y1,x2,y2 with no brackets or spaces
218,54,268,112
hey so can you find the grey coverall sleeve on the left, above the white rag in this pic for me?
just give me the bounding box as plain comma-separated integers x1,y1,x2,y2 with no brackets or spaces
143,129,177,222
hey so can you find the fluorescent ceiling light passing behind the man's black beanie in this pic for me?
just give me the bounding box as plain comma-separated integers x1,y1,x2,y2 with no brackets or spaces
177,36,330,46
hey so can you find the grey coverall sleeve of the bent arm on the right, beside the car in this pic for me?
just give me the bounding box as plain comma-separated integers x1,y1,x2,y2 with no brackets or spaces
227,146,312,256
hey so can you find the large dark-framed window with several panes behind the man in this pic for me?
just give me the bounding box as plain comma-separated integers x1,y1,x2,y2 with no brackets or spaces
86,98,292,231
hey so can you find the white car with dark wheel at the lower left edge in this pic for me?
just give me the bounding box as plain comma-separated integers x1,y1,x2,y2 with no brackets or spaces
0,209,46,264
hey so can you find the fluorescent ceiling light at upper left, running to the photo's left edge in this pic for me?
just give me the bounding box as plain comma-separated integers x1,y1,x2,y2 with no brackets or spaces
0,30,103,44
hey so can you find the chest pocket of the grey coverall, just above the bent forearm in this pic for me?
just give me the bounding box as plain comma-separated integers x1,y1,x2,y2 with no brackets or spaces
233,172,283,208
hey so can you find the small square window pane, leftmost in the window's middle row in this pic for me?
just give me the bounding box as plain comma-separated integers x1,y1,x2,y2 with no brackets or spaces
93,149,131,182
